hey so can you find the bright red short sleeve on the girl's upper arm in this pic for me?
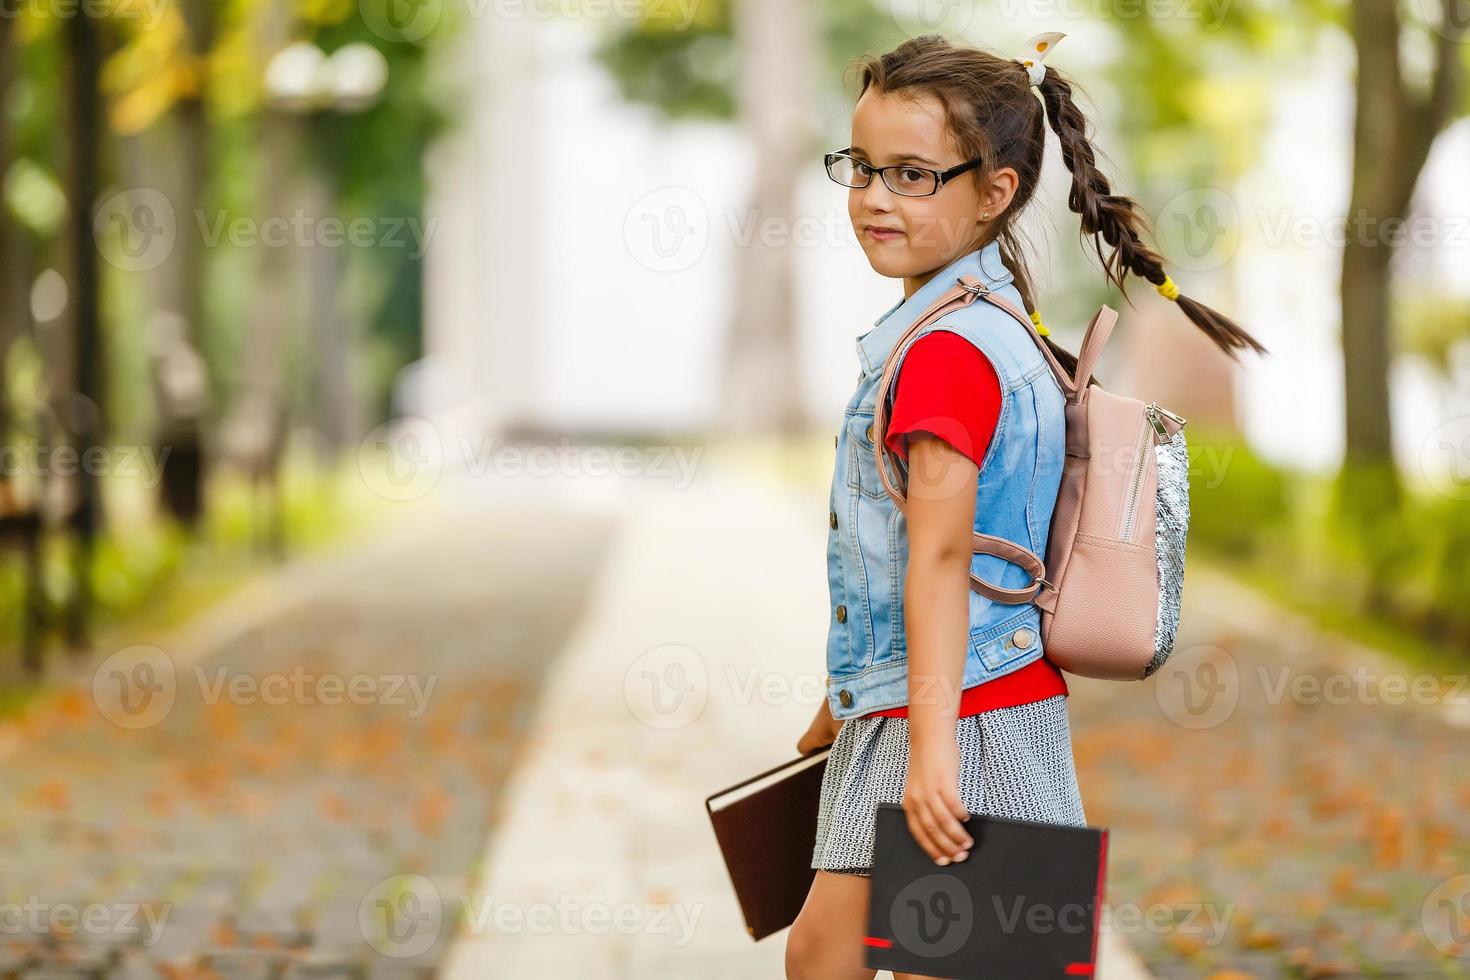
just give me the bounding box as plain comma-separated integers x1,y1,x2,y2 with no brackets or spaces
885,331,1001,466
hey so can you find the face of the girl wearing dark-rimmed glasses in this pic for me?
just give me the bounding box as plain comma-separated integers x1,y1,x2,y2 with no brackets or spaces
847,88,1016,297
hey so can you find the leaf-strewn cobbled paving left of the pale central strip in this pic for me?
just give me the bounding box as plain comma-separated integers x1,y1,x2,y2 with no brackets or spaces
0,473,609,980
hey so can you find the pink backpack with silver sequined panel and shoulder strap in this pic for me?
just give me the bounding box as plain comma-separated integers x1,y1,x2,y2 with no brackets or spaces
873,276,1189,680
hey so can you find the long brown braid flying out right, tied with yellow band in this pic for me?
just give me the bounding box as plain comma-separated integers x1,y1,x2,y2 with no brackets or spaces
1039,68,1267,360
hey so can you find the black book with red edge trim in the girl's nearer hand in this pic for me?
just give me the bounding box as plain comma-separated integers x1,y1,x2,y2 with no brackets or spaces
864,804,1108,980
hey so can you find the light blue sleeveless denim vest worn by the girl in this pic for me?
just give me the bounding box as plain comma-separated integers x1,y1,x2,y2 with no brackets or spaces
826,242,1066,720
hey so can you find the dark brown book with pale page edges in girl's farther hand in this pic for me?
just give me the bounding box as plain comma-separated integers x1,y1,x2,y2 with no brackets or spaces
704,746,832,942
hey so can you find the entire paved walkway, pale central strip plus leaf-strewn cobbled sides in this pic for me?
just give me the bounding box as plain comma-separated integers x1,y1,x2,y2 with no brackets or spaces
0,443,1470,980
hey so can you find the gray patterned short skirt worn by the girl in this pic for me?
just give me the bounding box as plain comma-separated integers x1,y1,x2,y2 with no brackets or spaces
811,693,1086,874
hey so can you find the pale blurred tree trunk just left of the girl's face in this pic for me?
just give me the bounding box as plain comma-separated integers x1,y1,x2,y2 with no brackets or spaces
714,0,820,432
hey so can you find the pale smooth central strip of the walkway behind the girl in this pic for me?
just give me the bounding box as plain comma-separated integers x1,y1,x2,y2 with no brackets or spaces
444,453,1142,980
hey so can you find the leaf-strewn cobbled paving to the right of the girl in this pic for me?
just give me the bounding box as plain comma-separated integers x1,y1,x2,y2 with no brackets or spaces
1072,566,1470,980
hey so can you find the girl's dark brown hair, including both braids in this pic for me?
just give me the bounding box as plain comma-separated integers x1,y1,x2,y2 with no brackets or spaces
851,34,1266,370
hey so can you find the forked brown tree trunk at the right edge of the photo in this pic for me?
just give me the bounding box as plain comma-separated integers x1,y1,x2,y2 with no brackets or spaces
1342,0,1466,469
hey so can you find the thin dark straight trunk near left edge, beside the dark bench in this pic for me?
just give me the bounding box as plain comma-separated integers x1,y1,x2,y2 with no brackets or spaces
62,5,106,649
